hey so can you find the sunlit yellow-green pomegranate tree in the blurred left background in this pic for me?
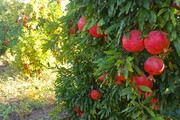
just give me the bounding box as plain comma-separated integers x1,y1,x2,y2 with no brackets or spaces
0,0,64,76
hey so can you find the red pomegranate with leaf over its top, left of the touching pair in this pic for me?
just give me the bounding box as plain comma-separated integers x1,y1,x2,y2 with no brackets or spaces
122,30,145,52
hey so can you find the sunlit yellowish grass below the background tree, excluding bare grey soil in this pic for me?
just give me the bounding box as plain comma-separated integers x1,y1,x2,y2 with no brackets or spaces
0,57,57,120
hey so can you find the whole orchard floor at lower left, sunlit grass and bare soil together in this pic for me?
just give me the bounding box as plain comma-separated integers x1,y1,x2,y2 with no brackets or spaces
0,57,66,120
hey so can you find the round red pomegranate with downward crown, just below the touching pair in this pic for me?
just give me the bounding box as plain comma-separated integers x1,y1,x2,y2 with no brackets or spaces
144,56,164,80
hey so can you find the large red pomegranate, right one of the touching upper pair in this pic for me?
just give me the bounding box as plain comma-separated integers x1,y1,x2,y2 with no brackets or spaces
144,31,170,54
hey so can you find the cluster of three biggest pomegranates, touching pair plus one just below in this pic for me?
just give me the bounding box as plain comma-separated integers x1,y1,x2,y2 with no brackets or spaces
122,30,170,80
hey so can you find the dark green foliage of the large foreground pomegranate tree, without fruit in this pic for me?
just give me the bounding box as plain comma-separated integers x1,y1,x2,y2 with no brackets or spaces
56,0,180,120
